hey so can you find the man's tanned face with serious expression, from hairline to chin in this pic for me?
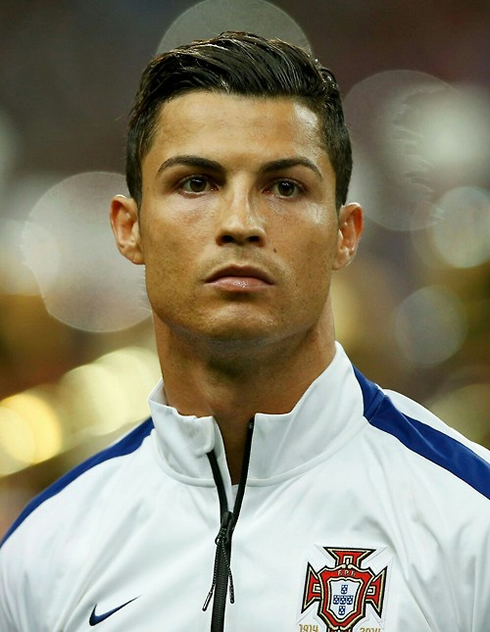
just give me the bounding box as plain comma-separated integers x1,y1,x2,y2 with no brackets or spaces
114,91,360,350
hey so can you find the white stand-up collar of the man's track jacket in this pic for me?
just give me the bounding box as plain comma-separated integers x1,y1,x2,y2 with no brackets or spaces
149,343,363,486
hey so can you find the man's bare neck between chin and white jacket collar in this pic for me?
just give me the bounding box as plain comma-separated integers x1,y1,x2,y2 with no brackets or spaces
155,308,335,482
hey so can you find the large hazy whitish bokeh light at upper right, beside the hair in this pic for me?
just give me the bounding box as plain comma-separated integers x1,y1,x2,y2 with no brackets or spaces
345,70,490,231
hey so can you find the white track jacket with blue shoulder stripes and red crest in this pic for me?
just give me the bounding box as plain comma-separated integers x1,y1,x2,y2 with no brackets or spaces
0,345,490,632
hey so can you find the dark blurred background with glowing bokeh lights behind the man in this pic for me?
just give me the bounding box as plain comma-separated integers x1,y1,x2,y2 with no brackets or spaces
0,0,490,534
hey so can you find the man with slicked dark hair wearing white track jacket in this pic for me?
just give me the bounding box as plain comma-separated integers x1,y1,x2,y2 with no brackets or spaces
0,33,490,632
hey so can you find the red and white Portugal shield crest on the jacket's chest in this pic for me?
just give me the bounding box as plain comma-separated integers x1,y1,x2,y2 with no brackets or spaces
301,547,388,632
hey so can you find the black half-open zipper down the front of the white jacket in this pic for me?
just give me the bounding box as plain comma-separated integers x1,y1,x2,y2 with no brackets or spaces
202,419,254,632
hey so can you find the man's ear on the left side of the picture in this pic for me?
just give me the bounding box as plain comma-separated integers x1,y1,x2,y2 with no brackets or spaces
111,195,144,264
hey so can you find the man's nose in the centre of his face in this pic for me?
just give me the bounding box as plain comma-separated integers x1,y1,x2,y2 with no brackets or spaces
216,185,266,246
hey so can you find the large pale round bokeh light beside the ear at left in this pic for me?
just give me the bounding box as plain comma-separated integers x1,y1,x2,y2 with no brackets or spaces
23,172,149,332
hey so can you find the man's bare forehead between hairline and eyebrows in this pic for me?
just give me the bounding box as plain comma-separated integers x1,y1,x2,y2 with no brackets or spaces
148,91,326,165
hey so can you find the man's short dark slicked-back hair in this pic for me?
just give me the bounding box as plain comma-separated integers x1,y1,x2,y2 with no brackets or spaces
126,31,352,208
